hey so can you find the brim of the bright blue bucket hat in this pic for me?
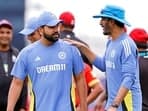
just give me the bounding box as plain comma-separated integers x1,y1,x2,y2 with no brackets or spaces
93,14,131,26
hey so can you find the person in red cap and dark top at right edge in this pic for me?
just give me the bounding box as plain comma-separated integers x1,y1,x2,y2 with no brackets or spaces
129,28,148,111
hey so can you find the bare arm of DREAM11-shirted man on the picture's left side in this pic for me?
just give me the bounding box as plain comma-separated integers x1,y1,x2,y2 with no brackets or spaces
7,78,23,111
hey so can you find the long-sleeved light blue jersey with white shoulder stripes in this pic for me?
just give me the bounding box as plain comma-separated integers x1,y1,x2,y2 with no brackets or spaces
94,33,142,111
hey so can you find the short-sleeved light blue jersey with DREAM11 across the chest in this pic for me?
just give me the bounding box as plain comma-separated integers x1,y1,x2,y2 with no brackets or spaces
11,40,84,111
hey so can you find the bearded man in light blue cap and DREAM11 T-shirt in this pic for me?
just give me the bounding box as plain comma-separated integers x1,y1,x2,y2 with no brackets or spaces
7,12,87,111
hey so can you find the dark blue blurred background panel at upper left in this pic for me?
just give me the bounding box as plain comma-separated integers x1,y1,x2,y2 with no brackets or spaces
0,0,25,49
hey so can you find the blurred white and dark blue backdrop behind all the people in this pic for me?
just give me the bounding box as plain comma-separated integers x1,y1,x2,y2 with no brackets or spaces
0,0,148,79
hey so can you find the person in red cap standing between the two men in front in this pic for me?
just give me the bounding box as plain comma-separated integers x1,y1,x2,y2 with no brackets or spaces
59,11,103,109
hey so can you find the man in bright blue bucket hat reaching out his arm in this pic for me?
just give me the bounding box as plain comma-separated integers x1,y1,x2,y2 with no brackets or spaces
65,5,142,111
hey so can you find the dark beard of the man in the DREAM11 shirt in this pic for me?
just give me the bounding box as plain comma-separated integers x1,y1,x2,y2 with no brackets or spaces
43,33,59,43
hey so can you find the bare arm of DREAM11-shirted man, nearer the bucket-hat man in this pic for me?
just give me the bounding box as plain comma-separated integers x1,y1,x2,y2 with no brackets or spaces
76,73,87,111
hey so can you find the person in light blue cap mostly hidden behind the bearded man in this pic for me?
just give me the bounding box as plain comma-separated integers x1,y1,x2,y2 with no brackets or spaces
19,17,41,111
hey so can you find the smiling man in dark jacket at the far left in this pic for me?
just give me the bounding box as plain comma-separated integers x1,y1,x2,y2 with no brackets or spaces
0,19,27,111
